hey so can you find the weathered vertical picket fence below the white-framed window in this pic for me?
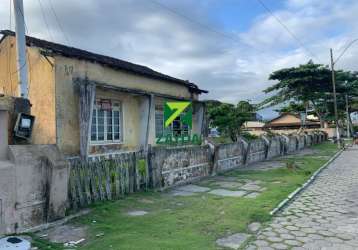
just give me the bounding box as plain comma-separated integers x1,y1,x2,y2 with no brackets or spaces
69,151,149,209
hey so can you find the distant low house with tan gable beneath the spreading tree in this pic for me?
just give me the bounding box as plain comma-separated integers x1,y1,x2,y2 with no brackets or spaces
265,113,320,130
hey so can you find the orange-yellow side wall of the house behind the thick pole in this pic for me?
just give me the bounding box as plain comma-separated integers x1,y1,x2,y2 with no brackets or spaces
0,36,56,144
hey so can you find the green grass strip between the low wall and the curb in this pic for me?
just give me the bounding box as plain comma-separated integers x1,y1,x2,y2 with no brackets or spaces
35,143,337,250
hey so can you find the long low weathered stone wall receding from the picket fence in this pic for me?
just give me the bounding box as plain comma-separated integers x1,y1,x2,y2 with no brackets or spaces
149,132,327,188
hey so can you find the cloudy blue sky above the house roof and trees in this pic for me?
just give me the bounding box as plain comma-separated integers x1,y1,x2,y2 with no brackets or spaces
0,0,358,119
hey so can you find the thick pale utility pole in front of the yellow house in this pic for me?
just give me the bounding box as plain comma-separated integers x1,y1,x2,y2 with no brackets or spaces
13,0,28,99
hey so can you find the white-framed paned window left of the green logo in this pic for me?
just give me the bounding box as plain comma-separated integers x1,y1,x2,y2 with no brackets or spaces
91,99,123,144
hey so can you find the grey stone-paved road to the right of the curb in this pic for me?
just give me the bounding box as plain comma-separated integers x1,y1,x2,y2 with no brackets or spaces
246,147,358,250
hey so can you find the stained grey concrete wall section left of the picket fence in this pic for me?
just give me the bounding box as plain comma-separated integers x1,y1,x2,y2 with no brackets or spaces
0,145,68,234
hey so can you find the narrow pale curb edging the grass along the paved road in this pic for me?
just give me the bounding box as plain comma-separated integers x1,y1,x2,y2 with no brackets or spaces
270,149,344,215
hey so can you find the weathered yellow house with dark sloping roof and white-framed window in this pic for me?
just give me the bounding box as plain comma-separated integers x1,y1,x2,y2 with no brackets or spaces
0,30,207,156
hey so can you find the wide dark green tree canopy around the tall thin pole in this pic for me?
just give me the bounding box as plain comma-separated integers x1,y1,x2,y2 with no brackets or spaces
260,61,358,127
